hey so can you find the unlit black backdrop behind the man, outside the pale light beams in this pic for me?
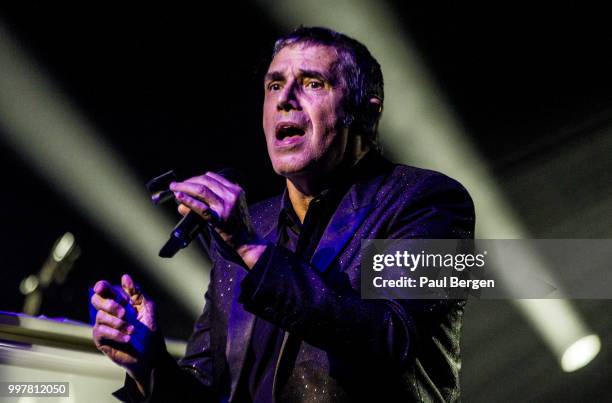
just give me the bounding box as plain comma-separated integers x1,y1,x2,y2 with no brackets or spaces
0,1,612,401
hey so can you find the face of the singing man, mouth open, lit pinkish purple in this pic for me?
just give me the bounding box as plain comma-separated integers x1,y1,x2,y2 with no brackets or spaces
263,44,348,178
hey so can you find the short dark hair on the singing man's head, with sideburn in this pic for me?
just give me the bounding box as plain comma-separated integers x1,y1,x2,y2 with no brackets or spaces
272,26,384,146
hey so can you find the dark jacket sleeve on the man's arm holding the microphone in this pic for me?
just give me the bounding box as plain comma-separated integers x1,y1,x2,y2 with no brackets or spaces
234,175,474,368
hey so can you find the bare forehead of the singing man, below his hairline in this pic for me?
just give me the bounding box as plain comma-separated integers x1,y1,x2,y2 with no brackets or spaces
268,43,338,73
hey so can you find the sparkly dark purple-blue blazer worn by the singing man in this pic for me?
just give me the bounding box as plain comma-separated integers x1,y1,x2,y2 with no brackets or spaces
124,155,474,402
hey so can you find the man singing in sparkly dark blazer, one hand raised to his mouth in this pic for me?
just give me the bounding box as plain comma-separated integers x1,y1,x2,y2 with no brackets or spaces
91,28,474,403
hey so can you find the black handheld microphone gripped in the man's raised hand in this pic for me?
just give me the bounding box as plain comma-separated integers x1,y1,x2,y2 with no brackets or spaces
147,168,240,258
